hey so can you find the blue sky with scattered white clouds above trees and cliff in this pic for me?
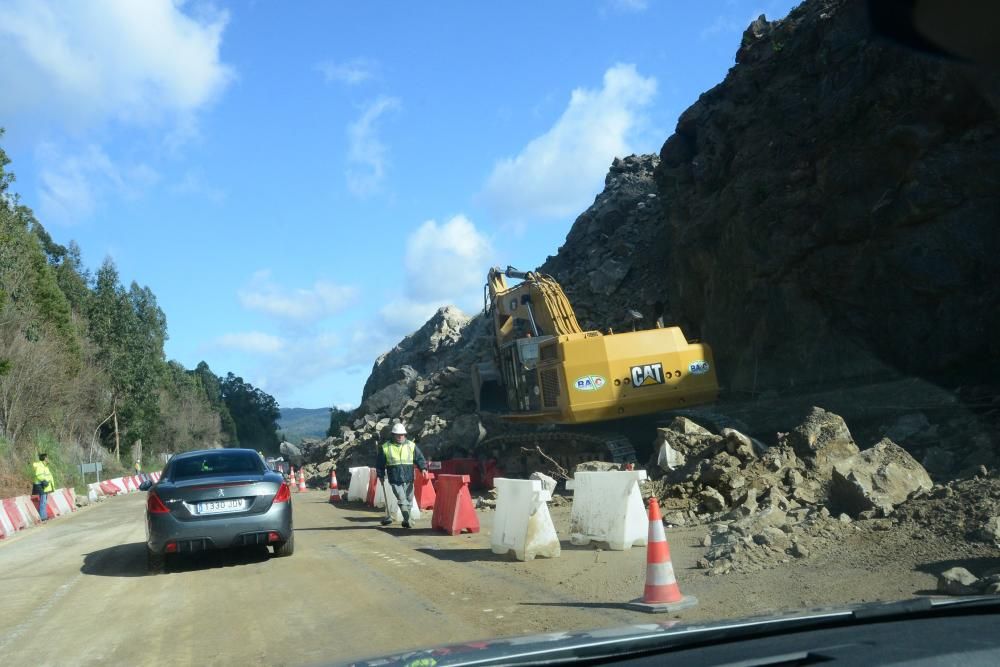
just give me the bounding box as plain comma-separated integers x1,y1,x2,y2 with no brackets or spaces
0,0,797,408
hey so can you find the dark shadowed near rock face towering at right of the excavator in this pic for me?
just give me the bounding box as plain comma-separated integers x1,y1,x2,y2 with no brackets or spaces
656,0,1000,391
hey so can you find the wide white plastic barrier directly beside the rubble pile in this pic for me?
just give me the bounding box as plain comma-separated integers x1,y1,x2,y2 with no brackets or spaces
566,470,649,551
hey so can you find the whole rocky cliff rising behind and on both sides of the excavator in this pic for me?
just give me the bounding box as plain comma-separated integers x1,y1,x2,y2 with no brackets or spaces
310,0,1000,482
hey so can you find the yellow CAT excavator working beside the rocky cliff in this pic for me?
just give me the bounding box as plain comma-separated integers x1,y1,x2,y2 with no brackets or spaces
472,266,719,474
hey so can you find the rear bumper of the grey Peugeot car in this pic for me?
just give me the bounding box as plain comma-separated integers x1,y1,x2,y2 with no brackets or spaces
146,502,292,553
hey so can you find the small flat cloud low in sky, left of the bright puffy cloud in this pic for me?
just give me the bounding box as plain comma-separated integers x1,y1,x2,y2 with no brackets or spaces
239,271,357,323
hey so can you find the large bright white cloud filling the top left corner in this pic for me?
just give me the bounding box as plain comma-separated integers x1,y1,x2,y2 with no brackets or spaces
0,0,233,125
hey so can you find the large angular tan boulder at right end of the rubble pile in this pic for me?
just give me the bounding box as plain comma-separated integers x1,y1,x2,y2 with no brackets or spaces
830,438,934,517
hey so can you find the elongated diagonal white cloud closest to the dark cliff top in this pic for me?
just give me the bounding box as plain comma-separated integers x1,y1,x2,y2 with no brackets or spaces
481,64,656,221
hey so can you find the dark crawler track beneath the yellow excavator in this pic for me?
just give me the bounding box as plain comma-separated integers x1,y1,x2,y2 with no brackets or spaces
476,430,636,478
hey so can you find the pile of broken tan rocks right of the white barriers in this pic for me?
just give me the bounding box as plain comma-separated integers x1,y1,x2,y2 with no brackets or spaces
646,407,948,574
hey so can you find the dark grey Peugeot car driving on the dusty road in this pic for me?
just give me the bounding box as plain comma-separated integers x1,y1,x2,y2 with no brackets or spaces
144,449,295,572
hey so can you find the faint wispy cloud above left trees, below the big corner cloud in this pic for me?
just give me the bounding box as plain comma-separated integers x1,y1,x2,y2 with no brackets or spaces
35,143,160,224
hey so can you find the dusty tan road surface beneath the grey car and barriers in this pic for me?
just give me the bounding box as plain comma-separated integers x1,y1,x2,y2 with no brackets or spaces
0,491,984,666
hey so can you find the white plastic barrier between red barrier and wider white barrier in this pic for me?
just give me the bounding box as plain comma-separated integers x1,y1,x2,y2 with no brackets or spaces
490,477,562,560
